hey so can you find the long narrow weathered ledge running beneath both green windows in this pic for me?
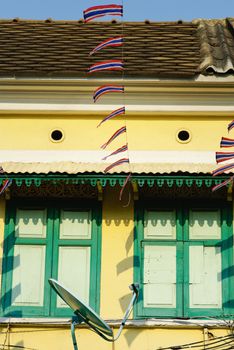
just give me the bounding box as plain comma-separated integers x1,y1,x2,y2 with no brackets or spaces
0,317,231,328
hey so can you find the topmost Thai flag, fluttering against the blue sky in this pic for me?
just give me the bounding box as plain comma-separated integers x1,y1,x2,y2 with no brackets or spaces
83,4,123,23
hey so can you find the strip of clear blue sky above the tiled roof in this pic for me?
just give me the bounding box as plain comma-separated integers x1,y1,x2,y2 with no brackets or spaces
0,0,234,21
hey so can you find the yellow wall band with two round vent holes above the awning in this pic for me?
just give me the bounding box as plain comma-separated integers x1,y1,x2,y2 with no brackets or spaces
0,114,232,150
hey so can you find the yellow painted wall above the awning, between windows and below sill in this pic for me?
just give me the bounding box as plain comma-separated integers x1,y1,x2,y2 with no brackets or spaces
0,115,231,350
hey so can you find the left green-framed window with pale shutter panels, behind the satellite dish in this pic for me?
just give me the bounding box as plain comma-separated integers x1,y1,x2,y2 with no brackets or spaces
2,201,101,317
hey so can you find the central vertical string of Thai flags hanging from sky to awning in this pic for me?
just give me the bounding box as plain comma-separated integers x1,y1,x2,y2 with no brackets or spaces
83,4,131,199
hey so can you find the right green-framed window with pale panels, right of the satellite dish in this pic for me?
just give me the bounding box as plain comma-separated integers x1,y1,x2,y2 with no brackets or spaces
135,203,234,318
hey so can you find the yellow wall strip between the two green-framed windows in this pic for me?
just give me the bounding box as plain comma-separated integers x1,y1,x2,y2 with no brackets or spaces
100,188,134,319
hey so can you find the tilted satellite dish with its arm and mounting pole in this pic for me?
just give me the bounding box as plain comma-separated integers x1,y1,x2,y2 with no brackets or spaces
49,278,139,350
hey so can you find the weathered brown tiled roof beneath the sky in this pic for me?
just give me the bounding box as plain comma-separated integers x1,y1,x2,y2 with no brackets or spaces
0,19,234,78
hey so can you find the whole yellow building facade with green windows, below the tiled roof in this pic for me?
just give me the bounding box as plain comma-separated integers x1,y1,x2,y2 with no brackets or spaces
0,18,234,350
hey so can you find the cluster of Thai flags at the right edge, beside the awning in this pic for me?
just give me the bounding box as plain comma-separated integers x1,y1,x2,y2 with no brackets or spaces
212,120,234,192
